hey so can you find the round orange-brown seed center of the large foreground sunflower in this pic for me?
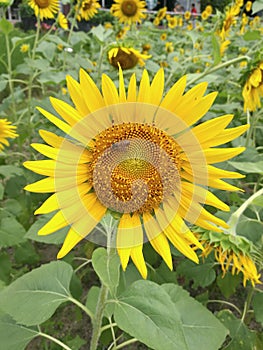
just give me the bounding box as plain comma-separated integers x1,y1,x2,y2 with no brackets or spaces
92,123,182,213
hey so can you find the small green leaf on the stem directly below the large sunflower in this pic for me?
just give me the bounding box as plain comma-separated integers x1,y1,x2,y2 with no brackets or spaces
92,248,120,296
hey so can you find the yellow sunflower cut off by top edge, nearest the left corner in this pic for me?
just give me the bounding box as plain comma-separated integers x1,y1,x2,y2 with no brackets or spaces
28,0,59,21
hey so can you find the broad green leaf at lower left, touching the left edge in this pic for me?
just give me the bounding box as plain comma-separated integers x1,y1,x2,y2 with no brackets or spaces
0,261,73,326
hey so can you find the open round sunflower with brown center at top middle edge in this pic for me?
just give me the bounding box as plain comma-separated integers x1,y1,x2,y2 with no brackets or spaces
110,0,146,24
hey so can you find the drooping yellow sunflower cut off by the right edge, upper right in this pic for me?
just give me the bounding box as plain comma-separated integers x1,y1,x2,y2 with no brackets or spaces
242,62,263,112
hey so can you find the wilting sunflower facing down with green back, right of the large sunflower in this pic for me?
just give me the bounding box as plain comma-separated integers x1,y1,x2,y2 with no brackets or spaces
199,232,261,287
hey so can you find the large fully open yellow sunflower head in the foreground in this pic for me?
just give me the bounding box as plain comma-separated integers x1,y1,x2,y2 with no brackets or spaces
24,69,250,278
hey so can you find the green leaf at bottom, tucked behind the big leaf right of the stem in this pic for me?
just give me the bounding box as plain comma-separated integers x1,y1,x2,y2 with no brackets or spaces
162,283,228,350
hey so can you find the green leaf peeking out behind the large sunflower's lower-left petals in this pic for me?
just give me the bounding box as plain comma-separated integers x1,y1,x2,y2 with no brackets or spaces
25,214,68,244
